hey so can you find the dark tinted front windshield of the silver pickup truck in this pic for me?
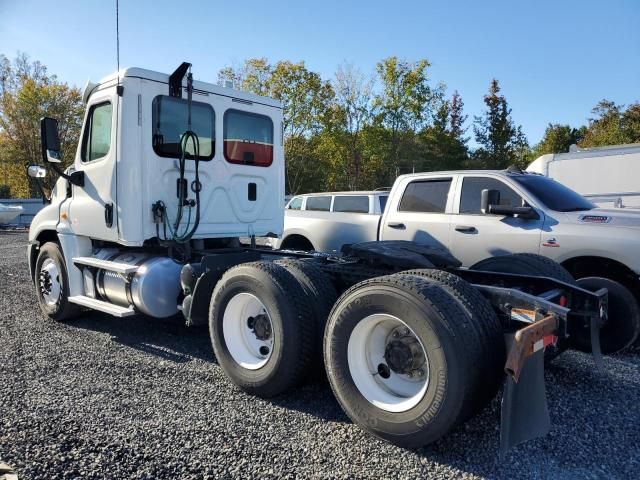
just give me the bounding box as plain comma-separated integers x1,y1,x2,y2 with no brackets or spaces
511,175,595,212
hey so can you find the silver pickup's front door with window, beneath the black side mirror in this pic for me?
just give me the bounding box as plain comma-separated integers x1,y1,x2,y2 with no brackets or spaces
451,174,544,267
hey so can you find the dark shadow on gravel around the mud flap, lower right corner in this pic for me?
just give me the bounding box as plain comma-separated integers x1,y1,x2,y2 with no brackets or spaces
416,350,640,479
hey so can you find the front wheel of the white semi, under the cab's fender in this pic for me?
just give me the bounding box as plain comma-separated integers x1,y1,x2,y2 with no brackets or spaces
34,242,82,322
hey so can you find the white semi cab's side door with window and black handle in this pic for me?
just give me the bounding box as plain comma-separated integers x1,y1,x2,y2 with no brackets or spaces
69,87,118,241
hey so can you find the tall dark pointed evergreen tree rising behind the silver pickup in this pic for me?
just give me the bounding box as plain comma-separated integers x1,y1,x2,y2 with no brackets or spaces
472,78,530,169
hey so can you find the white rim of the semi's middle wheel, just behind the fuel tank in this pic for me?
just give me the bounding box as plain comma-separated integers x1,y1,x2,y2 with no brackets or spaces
222,293,274,370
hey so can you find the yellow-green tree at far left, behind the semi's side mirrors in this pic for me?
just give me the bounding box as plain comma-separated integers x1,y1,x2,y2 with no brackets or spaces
0,54,84,196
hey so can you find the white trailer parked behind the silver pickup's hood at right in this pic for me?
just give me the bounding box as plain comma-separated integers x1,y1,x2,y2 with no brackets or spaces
527,143,640,208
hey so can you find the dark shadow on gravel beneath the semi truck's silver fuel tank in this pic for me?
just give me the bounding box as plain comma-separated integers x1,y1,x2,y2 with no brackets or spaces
69,312,214,363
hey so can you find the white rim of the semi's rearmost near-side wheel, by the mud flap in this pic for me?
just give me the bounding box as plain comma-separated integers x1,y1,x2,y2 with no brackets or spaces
347,314,429,413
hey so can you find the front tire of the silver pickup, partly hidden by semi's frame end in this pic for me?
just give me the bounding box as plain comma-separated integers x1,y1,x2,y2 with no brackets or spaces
573,277,640,353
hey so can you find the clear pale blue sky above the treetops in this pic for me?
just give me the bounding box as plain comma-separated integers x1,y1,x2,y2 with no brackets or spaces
0,0,640,144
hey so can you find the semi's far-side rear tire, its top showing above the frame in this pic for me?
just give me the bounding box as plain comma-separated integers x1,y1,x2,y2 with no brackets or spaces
471,253,578,362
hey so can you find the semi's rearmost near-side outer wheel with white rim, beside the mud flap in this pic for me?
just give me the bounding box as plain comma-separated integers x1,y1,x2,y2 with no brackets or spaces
324,274,483,448
